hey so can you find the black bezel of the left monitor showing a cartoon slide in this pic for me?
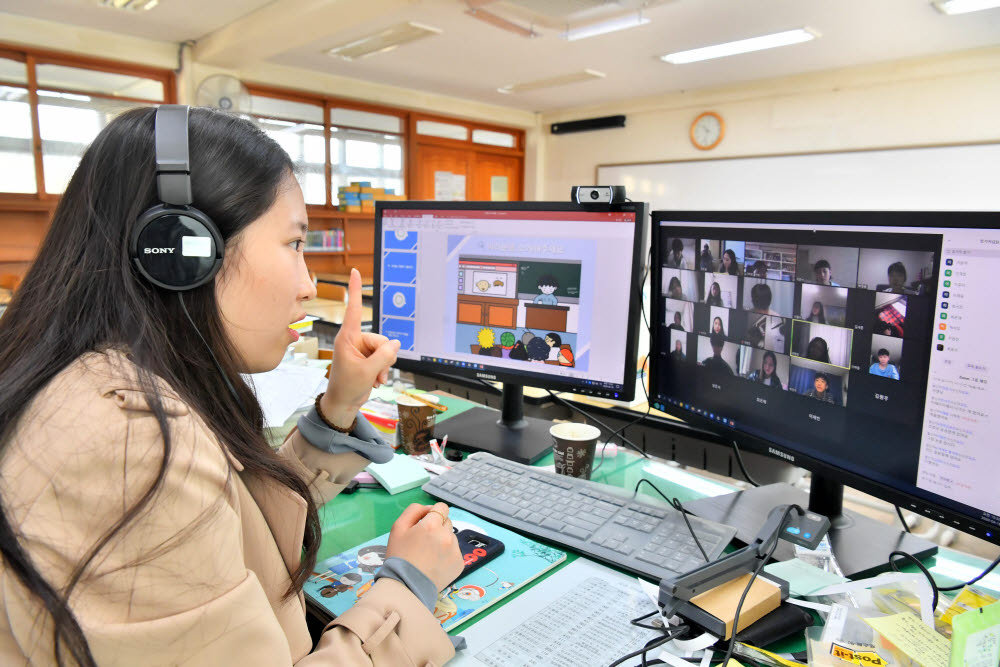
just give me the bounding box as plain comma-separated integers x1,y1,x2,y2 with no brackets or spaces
372,201,649,401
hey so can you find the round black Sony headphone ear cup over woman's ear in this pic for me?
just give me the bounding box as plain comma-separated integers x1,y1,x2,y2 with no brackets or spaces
131,204,223,292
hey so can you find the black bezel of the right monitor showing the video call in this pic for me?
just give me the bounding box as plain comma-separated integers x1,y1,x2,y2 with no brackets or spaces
649,210,1000,544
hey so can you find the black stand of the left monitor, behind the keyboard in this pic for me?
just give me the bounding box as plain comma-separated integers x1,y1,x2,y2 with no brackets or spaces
436,382,552,464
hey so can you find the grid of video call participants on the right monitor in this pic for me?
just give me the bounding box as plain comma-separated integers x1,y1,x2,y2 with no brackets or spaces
654,222,941,504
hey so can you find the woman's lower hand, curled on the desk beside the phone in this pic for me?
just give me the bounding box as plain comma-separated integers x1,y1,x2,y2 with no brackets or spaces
385,503,465,591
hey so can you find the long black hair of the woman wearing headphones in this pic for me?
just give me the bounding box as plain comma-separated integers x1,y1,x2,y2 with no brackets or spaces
0,108,320,667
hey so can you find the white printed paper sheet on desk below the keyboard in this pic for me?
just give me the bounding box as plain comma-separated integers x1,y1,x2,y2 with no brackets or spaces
448,558,668,667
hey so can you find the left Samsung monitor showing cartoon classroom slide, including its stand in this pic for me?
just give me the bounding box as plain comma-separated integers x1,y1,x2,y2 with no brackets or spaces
373,201,648,463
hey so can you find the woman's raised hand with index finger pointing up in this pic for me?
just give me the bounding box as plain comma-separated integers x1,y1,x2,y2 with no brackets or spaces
320,269,399,428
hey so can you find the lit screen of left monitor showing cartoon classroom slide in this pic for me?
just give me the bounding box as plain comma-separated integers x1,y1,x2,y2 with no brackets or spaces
378,208,636,386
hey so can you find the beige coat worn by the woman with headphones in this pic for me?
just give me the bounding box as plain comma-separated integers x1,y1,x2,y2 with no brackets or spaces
0,352,454,667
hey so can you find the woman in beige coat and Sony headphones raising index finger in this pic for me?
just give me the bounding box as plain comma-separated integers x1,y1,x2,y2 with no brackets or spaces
0,105,463,667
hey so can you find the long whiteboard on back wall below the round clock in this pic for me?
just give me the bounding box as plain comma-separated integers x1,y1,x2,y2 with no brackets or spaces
597,143,1000,211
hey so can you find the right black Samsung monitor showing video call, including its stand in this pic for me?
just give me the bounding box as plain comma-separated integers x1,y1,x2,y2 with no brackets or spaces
650,211,1000,575
